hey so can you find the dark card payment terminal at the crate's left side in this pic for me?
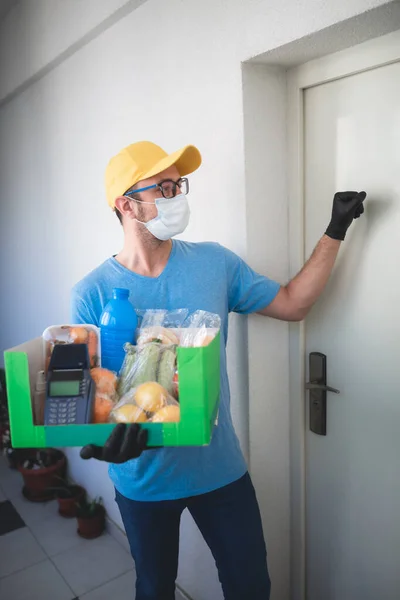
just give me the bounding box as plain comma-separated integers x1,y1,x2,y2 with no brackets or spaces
44,344,95,425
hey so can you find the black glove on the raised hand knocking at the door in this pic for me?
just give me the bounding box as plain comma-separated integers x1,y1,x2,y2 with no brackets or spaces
325,192,367,241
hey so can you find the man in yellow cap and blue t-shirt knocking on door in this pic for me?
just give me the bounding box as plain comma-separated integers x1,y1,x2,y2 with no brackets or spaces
72,142,366,600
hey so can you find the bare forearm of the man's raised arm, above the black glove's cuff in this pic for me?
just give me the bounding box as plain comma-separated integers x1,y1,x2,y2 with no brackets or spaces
286,235,341,318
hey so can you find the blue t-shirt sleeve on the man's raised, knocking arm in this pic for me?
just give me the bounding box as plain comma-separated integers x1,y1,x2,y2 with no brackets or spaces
224,248,281,314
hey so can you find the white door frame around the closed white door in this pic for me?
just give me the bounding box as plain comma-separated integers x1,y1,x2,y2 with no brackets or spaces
287,30,400,600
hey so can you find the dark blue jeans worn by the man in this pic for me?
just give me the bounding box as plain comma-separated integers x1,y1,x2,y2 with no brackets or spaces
116,473,271,600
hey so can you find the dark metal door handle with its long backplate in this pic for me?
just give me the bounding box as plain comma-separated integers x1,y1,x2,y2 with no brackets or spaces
305,352,340,435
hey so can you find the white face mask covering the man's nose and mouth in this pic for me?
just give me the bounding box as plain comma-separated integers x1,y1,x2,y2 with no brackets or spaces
129,194,190,242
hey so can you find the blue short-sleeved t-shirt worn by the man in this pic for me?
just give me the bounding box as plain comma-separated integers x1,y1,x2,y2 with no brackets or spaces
72,240,280,501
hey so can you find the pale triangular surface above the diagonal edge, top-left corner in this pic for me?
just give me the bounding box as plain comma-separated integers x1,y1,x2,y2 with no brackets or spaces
0,0,146,100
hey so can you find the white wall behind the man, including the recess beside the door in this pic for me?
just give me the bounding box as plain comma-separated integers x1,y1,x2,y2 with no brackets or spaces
0,0,390,600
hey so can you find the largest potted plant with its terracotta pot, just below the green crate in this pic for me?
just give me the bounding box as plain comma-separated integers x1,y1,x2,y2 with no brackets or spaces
17,448,67,502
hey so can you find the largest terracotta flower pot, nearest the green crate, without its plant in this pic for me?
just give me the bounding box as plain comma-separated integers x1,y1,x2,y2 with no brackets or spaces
18,451,67,502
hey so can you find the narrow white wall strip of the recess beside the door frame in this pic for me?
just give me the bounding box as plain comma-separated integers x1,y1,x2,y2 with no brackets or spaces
243,64,290,598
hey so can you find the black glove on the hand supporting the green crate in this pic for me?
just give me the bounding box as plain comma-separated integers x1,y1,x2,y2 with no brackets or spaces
80,423,148,463
